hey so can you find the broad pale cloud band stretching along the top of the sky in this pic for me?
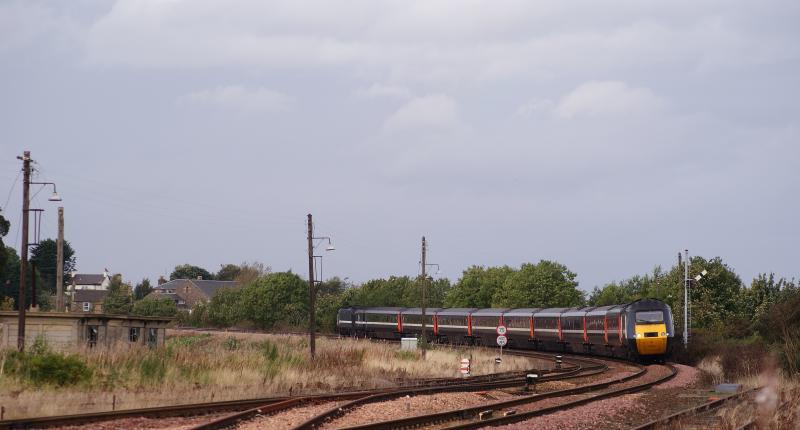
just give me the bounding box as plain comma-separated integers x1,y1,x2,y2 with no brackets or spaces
87,0,800,84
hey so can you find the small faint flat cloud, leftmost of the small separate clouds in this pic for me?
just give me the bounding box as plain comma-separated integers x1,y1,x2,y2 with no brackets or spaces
179,85,294,112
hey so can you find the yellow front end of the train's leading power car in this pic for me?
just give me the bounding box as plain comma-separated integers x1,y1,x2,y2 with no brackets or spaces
627,299,675,359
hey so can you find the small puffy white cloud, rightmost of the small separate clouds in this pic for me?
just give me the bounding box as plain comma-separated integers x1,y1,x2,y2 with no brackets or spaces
553,81,664,118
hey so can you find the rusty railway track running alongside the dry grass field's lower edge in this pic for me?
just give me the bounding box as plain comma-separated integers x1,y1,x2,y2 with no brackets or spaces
0,351,580,430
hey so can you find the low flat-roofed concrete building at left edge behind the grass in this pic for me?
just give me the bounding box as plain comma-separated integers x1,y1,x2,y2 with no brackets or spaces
0,311,172,349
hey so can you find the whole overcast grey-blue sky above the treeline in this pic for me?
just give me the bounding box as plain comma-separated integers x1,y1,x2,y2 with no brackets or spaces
0,0,800,290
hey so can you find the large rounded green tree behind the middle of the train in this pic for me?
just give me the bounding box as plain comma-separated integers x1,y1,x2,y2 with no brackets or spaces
492,260,585,308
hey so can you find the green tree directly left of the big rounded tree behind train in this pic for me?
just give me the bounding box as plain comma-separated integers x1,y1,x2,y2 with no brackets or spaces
444,266,514,308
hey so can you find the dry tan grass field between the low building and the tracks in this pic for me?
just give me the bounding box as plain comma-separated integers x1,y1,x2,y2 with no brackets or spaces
0,331,547,419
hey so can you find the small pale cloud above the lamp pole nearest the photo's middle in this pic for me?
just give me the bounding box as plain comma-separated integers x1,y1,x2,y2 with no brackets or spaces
383,94,460,132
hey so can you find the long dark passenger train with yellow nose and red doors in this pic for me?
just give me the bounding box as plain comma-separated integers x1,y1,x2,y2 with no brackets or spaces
336,299,675,361
